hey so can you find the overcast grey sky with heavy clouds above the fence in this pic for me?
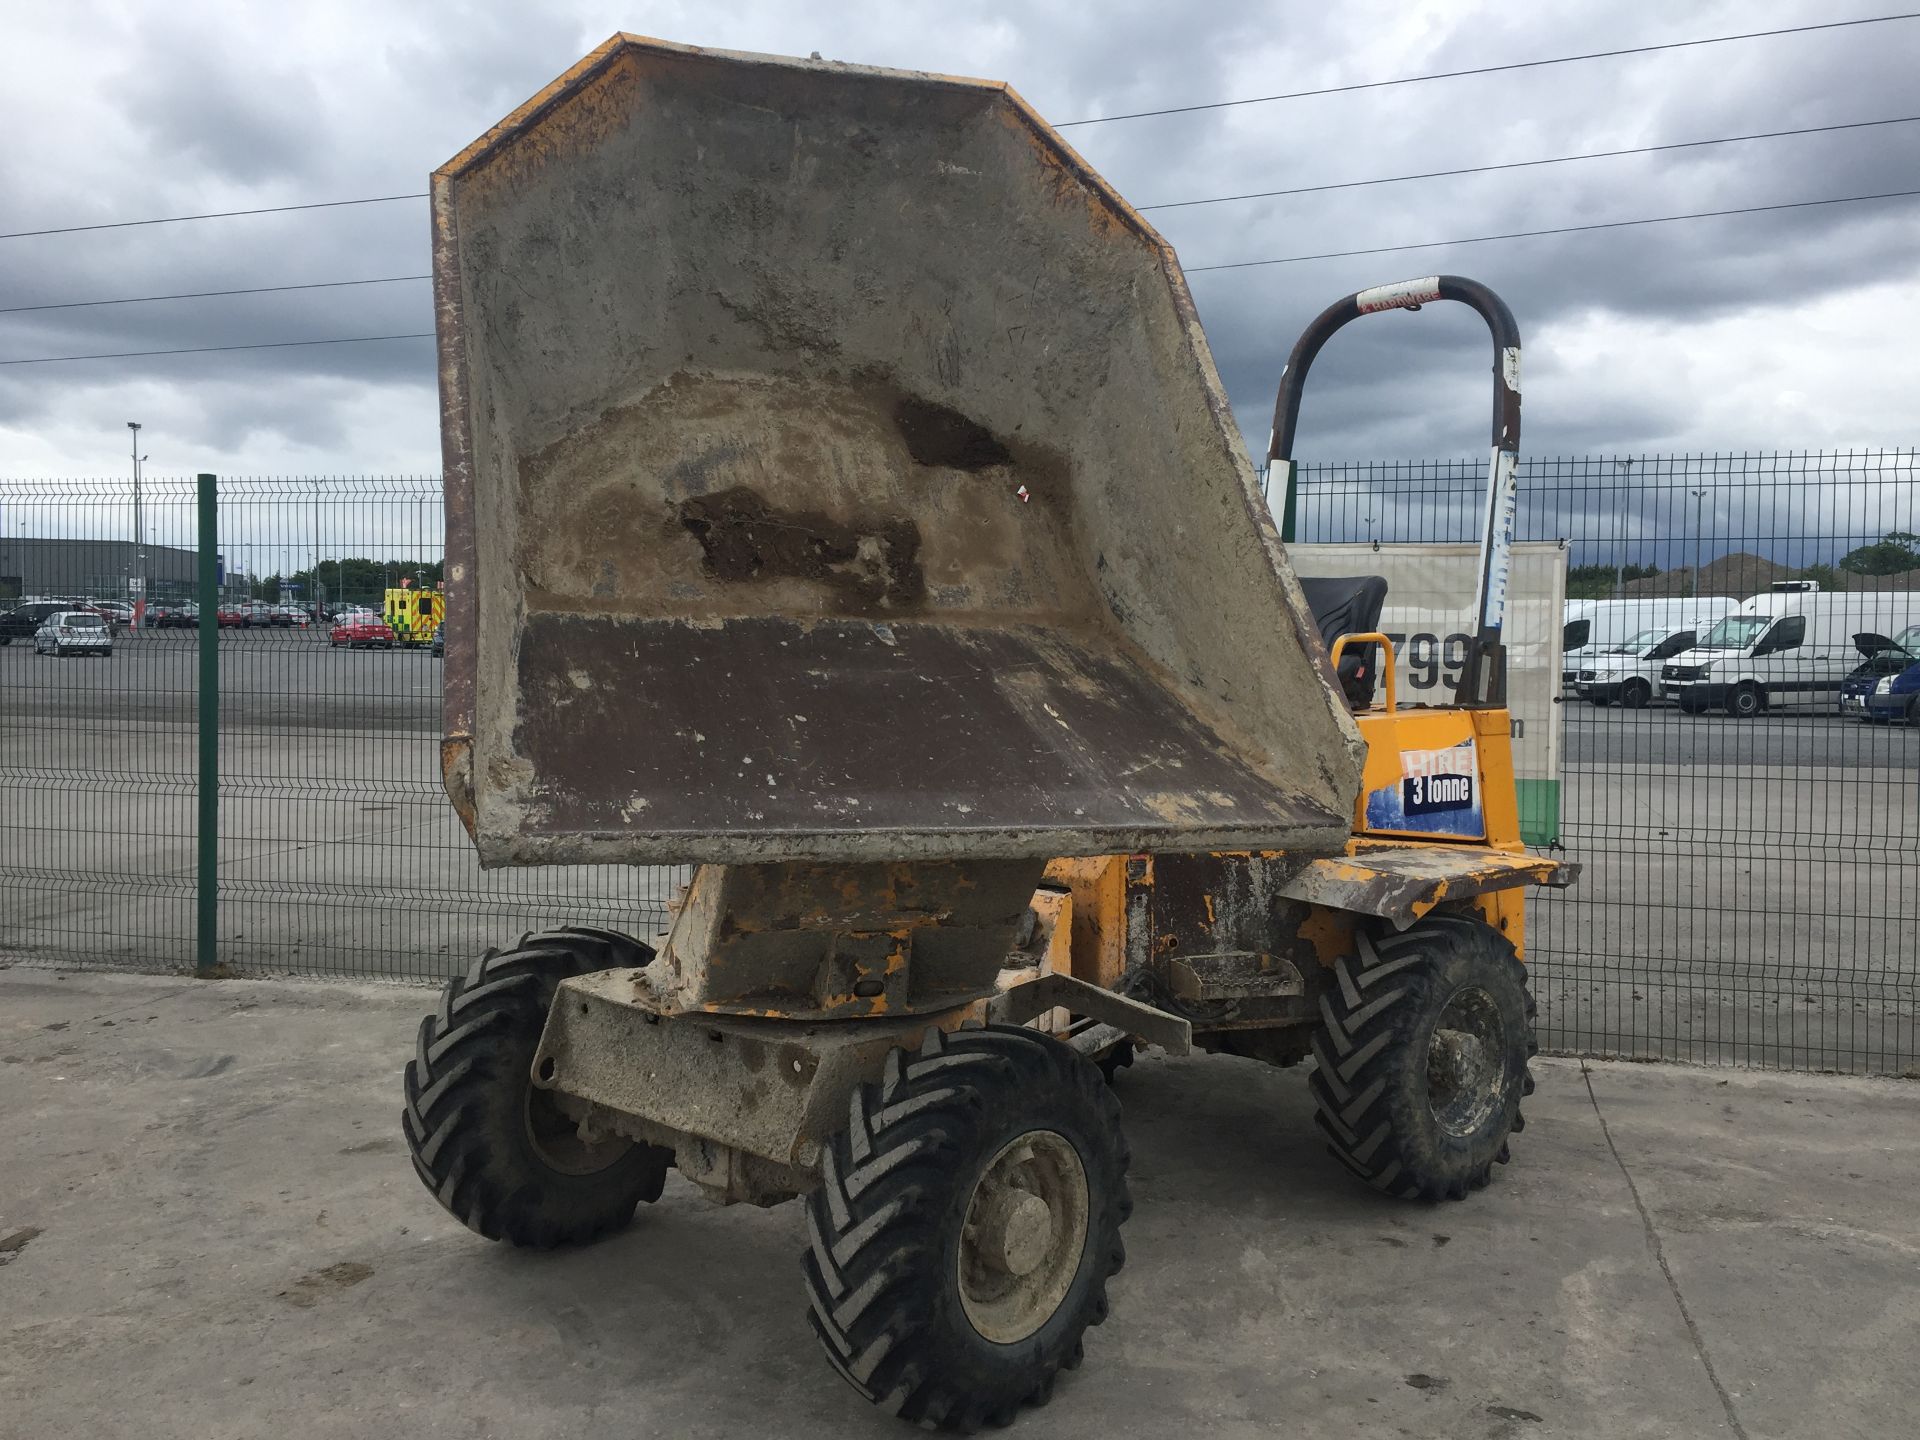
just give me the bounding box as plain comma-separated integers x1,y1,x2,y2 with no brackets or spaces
0,0,1920,487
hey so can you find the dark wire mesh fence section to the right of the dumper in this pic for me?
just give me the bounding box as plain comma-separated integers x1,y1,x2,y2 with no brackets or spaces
1298,449,1920,1073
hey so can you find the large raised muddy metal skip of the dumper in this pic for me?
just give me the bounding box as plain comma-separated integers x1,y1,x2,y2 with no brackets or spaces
434,36,1359,864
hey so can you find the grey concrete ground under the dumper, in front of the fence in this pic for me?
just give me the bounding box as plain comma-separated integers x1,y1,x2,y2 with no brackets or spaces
0,966,1920,1440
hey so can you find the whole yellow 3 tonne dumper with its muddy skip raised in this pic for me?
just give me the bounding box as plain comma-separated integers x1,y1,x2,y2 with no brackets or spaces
405,36,1567,1428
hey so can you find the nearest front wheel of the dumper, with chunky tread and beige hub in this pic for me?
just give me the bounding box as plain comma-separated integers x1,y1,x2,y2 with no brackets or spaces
803,1025,1133,1432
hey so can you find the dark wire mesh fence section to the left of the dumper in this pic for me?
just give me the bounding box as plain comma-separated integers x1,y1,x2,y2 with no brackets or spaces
0,476,678,977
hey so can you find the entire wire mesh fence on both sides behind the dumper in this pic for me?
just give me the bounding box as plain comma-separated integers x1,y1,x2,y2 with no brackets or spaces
0,451,1920,1073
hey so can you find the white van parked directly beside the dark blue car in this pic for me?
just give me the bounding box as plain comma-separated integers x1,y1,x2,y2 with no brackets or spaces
1661,589,1920,716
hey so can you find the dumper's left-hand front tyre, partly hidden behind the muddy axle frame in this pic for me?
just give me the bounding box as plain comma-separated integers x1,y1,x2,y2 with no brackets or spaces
403,929,672,1250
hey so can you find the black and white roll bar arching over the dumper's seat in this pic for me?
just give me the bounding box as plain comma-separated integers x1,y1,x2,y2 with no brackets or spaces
1267,275,1521,707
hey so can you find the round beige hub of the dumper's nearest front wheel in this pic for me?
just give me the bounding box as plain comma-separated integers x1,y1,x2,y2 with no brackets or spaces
958,1131,1089,1344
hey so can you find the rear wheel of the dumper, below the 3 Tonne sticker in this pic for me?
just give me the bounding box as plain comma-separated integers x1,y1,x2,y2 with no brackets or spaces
1308,916,1538,1200
